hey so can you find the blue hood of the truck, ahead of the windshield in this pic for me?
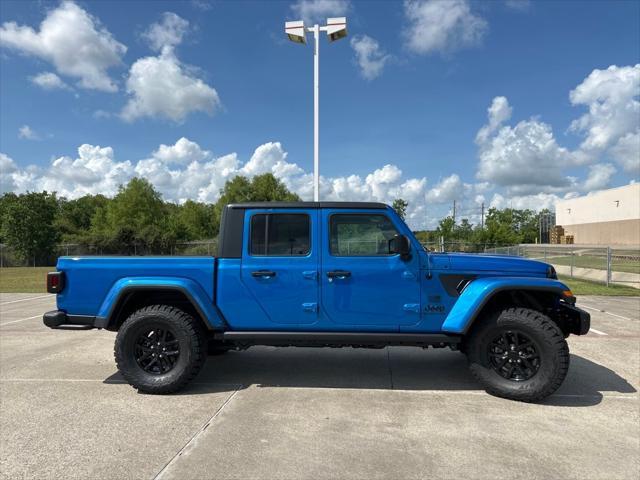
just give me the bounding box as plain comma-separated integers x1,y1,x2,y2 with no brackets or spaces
448,253,555,277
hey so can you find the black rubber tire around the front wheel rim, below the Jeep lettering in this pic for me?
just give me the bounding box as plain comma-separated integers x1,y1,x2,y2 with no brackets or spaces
465,307,570,402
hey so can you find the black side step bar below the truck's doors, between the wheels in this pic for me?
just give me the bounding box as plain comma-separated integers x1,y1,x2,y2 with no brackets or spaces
214,331,461,347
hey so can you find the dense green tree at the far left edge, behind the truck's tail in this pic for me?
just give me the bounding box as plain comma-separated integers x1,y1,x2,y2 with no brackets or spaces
1,191,60,266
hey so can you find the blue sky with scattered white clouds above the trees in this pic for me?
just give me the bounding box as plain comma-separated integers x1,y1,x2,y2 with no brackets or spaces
0,0,640,227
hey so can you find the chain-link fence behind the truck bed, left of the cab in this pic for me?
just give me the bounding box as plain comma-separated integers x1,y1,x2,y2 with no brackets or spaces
0,239,218,268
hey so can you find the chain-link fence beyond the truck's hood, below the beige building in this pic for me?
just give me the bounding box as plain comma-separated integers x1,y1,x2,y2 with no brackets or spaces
485,244,640,287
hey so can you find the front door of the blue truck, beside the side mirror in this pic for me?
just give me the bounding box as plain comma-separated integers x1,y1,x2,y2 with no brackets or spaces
320,210,420,331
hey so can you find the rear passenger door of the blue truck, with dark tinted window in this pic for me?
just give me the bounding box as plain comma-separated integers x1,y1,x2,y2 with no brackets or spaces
241,209,319,326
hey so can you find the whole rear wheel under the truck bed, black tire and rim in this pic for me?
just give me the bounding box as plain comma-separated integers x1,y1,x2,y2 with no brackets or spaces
114,305,206,394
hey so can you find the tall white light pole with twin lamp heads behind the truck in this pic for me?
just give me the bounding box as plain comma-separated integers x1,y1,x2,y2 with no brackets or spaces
284,17,347,202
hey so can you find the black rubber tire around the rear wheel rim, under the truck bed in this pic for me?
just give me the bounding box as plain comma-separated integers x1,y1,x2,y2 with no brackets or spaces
114,305,207,394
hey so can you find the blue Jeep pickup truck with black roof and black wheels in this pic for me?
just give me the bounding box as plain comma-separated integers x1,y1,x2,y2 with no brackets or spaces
44,202,590,401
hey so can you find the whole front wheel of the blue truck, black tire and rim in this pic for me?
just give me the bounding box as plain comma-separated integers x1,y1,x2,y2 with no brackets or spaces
465,308,569,402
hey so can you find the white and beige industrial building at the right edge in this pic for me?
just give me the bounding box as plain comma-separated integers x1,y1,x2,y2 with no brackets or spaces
556,183,640,246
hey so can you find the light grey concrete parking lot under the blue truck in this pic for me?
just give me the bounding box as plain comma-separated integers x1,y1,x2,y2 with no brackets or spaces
0,294,640,479
